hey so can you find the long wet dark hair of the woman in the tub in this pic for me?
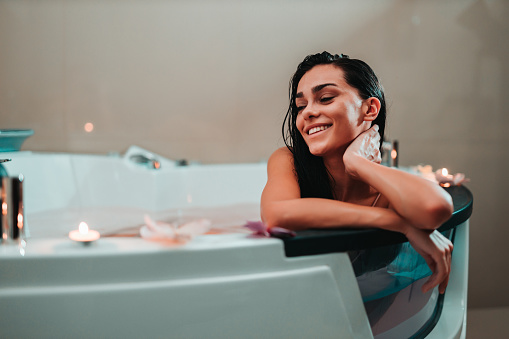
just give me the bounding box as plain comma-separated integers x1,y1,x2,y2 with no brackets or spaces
283,52,386,199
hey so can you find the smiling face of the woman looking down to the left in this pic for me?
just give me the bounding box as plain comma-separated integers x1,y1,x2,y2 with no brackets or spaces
295,65,371,156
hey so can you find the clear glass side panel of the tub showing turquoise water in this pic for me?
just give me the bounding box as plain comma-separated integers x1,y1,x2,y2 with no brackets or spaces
349,230,453,337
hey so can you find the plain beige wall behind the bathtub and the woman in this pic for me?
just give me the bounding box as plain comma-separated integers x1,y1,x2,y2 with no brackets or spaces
0,0,509,307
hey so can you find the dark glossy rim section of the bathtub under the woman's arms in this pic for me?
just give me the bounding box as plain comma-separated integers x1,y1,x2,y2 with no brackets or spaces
283,186,474,257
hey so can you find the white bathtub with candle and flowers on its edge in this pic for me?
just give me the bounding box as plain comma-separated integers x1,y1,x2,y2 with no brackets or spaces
0,147,468,338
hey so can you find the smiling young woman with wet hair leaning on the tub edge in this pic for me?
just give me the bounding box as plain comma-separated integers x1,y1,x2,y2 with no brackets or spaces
261,52,453,293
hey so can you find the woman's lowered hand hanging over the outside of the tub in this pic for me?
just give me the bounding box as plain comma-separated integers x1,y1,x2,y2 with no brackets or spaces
405,227,453,294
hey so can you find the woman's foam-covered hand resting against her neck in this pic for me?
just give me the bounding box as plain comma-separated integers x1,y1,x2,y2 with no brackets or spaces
343,125,382,177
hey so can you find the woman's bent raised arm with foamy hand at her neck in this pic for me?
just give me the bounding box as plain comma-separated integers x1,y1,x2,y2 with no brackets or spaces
343,126,453,230
